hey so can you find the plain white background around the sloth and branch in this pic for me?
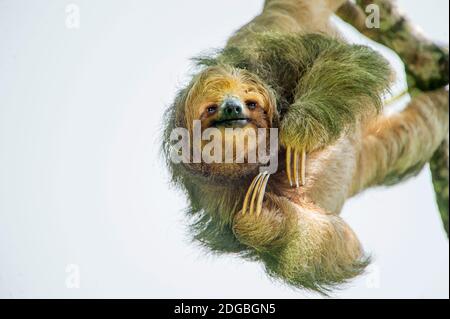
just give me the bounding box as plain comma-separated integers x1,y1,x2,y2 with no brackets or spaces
0,0,449,298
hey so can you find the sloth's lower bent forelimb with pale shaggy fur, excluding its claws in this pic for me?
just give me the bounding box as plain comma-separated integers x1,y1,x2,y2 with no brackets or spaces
234,194,368,292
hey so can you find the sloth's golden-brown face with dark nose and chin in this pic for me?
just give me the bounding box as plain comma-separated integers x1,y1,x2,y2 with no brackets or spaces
184,66,276,177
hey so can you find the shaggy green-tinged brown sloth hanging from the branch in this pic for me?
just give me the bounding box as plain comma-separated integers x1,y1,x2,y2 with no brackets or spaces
163,0,448,294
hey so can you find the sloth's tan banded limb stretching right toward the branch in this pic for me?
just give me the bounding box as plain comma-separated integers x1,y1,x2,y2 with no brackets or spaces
353,89,449,194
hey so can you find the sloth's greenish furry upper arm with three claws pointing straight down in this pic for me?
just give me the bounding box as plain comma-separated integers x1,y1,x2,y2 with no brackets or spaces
280,44,390,187
